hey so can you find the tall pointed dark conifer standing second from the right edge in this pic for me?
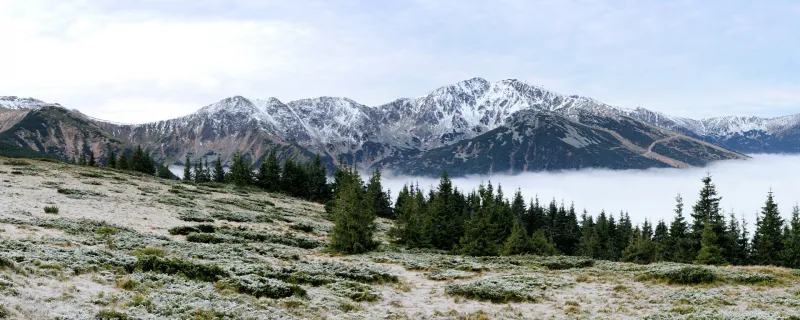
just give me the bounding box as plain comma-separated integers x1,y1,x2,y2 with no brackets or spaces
753,191,783,266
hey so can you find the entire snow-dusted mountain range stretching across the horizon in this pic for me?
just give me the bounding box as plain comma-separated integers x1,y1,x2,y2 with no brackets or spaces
0,78,800,175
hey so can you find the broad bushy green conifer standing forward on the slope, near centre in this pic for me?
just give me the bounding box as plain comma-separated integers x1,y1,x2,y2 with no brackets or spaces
330,165,377,253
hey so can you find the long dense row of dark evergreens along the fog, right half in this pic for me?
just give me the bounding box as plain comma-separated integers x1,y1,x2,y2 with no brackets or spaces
389,172,800,268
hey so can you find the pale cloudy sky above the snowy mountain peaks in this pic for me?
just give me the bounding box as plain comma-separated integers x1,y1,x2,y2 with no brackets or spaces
0,0,800,122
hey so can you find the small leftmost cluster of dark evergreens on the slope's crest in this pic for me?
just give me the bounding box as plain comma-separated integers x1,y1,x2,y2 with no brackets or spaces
77,146,174,179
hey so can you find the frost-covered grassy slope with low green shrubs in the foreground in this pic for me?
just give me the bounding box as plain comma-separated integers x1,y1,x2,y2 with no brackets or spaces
0,159,800,319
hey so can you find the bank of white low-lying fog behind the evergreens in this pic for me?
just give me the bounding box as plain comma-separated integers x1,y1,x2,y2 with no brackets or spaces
383,155,800,229
